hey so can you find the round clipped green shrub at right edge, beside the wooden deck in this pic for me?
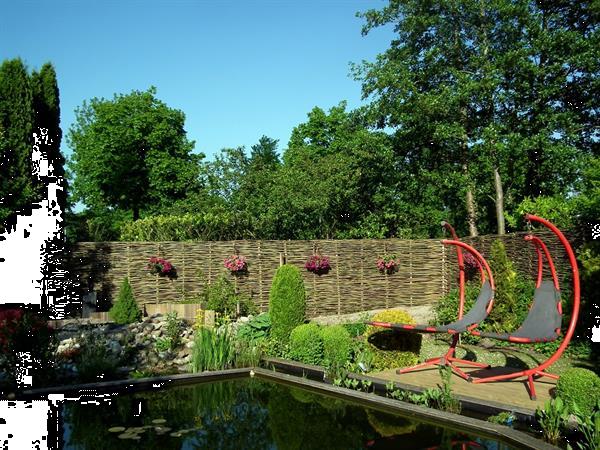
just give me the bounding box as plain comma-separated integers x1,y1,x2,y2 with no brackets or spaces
556,367,600,416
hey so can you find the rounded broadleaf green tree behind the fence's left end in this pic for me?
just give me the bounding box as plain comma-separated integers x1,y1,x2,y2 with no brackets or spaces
68,87,202,220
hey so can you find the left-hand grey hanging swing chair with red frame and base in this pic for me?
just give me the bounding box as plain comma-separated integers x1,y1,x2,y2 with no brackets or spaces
367,222,495,380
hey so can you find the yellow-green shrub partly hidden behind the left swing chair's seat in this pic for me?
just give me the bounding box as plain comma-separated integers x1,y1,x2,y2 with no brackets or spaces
365,309,421,370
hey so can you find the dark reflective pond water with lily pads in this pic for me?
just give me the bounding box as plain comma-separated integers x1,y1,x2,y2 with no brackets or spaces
61,379,513,450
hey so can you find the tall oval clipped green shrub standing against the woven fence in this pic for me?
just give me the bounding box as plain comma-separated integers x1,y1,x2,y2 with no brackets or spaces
269,264,306,344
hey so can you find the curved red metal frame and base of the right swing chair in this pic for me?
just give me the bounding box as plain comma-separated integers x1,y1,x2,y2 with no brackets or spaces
468,214,580,400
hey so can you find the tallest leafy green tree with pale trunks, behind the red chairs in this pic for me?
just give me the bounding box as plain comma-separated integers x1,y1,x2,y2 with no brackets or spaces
355,0,599,234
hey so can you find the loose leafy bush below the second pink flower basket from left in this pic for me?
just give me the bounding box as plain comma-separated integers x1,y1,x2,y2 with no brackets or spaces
203,274,256,317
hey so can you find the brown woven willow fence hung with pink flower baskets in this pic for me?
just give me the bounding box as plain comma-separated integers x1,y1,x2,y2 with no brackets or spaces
72,231,568,317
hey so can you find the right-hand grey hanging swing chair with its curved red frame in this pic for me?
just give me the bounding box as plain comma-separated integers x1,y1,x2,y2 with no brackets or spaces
467,214,580,400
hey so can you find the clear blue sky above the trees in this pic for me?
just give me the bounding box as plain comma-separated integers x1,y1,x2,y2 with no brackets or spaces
0,0,393,159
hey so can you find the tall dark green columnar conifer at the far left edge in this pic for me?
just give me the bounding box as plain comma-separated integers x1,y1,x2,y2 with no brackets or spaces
0,58,39,228
